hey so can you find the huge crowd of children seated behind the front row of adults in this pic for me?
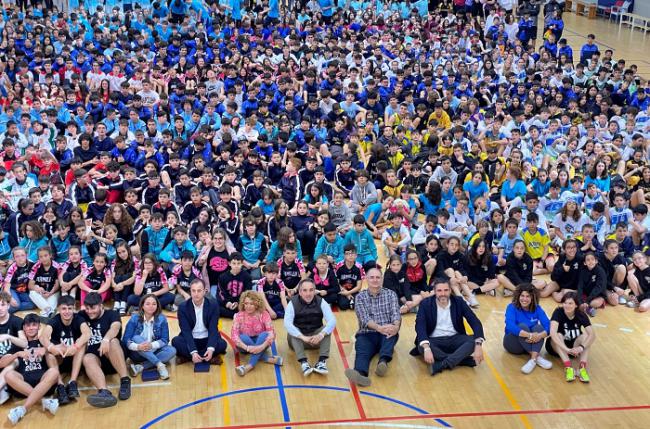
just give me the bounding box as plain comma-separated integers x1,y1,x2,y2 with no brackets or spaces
0,0,650,421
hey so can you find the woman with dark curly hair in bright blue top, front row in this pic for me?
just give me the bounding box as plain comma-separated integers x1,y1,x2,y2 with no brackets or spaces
503,283,553,374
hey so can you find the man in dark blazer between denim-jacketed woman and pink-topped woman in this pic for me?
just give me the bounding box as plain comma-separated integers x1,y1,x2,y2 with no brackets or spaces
172,279,227,365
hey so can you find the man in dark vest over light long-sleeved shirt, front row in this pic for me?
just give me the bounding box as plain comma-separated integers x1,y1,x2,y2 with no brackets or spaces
284,279,336,376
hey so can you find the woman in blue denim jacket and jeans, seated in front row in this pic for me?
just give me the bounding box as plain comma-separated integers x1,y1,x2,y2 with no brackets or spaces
122,294,176,380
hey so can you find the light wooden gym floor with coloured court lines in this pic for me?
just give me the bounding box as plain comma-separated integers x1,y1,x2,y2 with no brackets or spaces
0,14,650,429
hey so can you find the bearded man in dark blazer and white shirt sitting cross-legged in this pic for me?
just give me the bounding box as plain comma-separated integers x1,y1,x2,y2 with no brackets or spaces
411,281,484,375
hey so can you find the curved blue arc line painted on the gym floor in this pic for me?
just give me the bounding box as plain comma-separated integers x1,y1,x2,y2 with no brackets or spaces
140,384,452,429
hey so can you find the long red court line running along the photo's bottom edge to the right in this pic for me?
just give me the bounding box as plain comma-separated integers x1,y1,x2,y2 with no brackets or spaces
195,405,650,429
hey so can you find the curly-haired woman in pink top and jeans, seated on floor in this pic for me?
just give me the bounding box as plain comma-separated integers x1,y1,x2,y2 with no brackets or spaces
230,290,283,377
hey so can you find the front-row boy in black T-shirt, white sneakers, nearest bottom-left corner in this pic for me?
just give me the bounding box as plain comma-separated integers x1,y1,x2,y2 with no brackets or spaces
5,314,59,425
